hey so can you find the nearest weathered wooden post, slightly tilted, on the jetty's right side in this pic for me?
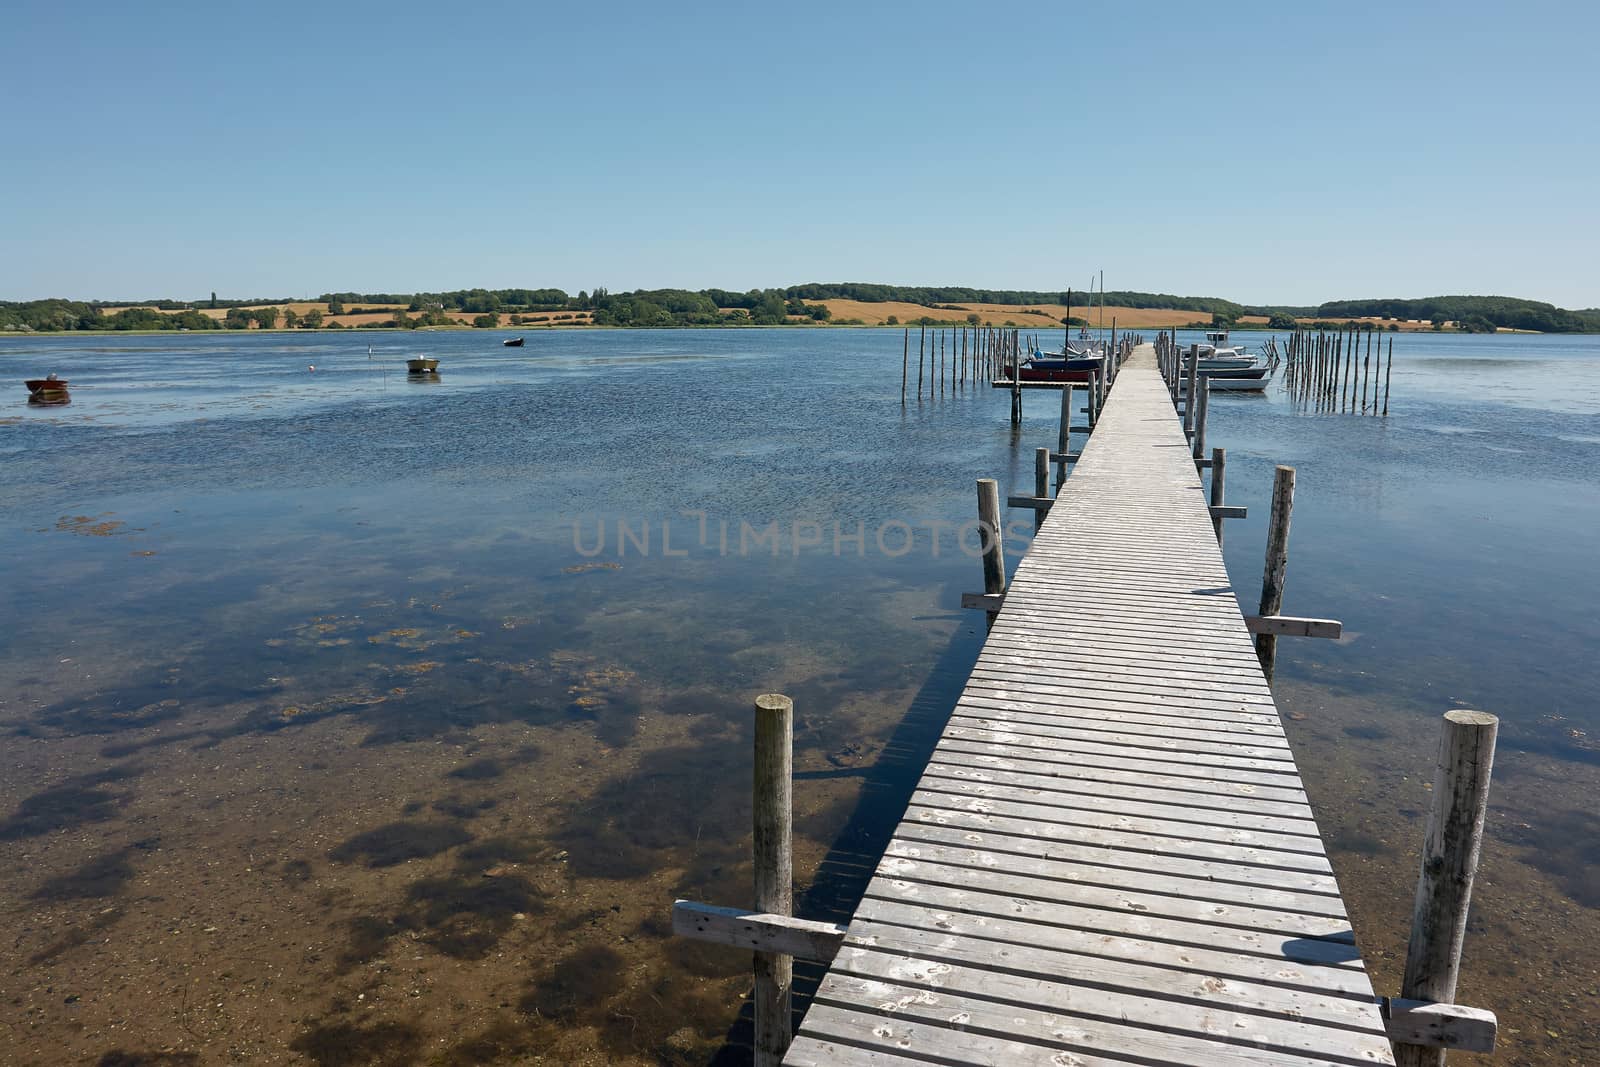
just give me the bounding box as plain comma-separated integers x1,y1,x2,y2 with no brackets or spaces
1395,710,1499,1067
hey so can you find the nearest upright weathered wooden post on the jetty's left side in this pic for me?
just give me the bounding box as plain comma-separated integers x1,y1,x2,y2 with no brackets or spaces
754,693,795,1067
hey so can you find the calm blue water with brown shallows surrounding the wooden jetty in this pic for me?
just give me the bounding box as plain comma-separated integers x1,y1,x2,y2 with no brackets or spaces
0,330,1600,1065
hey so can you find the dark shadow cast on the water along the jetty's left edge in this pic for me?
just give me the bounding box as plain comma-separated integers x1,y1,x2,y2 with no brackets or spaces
712,607,984,1067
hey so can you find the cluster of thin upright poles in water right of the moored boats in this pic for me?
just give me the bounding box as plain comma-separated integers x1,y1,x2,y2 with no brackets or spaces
1267,330,1395,416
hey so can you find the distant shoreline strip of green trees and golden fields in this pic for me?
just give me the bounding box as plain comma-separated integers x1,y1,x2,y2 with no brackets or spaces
9,282,1600,333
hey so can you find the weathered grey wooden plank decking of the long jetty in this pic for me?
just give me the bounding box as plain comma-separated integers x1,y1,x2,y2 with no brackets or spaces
784,346,1394,1065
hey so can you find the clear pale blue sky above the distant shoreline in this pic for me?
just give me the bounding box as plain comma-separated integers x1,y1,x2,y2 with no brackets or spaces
0,0,1600,307
